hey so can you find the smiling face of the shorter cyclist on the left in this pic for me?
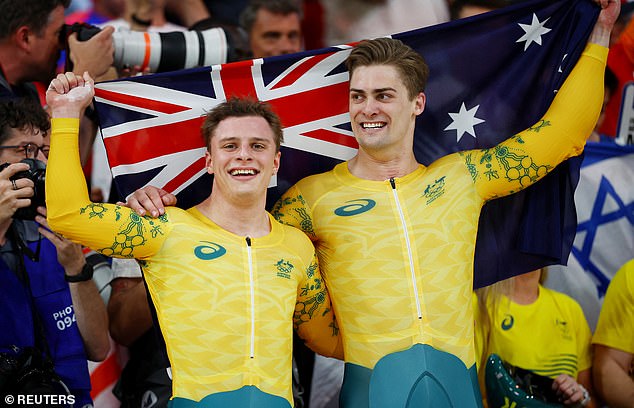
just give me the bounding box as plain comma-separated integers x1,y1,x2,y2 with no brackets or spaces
206,116,280,204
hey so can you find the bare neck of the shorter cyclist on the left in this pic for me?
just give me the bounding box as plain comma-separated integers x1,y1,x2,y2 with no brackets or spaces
196,196,271,238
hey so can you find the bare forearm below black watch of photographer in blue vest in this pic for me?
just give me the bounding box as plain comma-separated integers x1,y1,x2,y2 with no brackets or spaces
69,280,110,361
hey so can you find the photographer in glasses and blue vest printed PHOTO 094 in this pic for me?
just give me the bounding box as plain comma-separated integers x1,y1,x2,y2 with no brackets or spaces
0,98,110,407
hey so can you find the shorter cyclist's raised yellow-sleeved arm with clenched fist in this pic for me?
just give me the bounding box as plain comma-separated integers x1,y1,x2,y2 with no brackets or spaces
46,72,170,258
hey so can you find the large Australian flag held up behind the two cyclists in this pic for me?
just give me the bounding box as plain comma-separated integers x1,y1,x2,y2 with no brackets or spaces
95,0,599,287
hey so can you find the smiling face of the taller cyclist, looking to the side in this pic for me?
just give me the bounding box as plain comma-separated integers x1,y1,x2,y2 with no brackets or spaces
349,65,425,155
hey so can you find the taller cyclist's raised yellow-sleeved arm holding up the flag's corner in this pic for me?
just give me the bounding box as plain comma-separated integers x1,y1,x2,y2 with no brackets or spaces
461,0,620,200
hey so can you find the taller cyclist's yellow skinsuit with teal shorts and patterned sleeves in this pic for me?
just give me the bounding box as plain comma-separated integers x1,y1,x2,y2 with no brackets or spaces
272,44,607,408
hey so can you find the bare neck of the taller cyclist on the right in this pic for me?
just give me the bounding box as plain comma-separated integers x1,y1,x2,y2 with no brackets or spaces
348,149,419,181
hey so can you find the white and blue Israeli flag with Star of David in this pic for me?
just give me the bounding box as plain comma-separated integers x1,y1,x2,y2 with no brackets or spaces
547,142,634,330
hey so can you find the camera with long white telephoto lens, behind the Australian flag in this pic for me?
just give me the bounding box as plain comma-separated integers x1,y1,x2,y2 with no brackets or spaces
61,23,249,72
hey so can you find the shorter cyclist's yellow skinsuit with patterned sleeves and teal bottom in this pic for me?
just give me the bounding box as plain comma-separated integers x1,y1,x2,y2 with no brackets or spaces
46,119,341,408
